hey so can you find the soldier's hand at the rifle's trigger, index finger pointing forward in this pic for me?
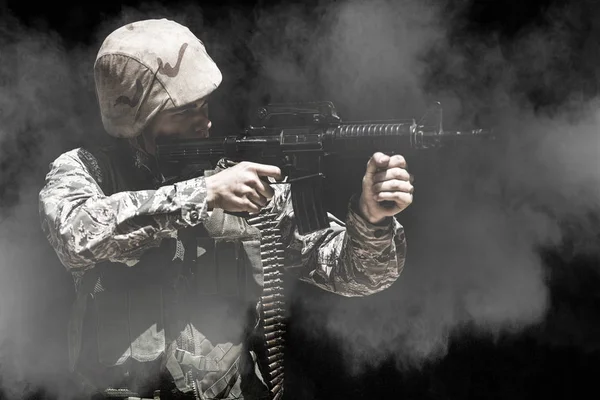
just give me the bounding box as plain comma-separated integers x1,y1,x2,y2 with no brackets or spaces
206,161,281,214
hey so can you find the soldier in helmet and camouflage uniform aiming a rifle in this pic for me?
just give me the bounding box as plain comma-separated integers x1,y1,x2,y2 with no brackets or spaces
39,19,413,399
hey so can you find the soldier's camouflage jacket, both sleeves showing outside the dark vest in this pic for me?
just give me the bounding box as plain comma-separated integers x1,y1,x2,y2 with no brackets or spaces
39,143,406,397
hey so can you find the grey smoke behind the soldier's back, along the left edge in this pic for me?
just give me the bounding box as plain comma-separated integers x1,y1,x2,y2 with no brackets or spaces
0,11,98,398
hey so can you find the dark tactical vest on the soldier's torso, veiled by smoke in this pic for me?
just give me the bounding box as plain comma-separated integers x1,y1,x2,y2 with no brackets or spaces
69,146,283,399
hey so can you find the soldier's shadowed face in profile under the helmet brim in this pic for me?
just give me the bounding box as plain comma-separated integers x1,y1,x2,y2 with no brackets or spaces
143,98,211,154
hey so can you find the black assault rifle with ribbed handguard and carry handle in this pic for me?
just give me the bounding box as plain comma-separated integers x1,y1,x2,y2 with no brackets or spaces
156,101,493,234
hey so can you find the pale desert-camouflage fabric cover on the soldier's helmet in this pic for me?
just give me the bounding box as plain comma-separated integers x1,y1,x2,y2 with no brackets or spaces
94,19,222,138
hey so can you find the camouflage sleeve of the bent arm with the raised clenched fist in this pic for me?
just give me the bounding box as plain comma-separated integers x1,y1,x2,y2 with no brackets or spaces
272,185,406,296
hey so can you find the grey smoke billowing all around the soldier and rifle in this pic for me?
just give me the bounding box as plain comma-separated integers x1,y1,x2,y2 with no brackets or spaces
0,0,600,399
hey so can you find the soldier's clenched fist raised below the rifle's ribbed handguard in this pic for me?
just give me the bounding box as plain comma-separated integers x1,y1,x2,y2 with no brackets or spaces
359,153,414,223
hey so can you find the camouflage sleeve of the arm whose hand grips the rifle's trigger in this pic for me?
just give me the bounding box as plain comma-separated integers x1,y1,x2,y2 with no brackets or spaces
39,149,208,271
